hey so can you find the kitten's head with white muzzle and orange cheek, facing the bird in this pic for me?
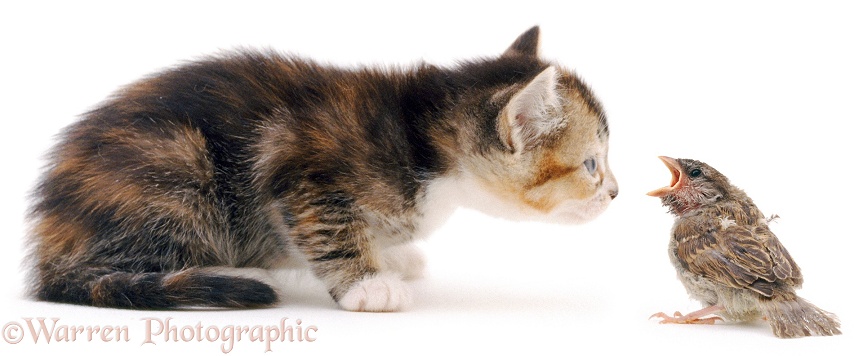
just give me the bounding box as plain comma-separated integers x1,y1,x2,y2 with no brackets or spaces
452,28,618,223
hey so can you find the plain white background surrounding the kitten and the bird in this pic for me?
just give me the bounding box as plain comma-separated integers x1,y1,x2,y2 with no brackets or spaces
0,1,863,355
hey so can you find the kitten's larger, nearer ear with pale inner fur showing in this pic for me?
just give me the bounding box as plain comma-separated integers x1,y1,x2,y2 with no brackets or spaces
498,66,563,153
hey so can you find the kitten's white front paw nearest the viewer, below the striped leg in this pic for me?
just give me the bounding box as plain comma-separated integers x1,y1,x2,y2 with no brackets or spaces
339,273,411,312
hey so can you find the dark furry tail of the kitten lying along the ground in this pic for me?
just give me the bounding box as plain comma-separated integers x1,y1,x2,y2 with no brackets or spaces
35,267,278,309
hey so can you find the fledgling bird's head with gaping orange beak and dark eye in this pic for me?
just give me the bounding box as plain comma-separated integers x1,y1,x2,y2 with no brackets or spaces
647,156,734,216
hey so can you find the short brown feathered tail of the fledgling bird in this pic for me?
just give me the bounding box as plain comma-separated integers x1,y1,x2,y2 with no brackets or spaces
759,294,842,338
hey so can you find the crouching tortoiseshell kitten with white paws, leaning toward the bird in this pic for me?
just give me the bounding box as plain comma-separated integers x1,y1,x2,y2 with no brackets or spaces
30,27,617,311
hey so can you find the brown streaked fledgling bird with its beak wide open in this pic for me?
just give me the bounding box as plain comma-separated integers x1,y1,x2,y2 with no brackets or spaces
647,157,841,338
